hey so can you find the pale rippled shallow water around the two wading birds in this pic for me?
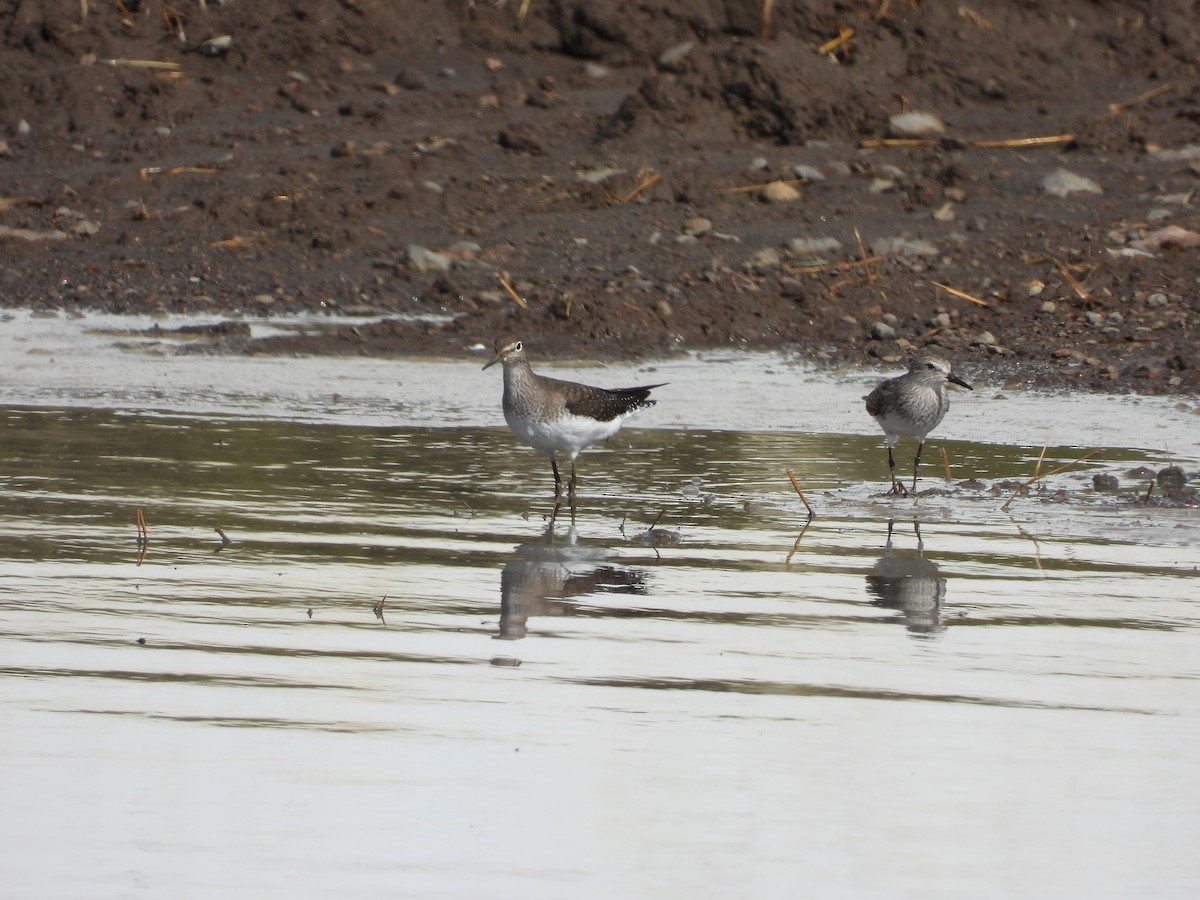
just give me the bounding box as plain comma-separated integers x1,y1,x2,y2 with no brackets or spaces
0,312,1200,898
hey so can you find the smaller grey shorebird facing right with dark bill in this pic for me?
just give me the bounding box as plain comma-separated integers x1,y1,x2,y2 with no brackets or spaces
866,356,974,493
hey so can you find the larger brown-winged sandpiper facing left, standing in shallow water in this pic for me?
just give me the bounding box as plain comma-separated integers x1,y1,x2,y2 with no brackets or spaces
484,337,662,518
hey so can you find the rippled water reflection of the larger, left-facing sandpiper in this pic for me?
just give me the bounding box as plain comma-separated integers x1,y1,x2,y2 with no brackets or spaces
497,524,646,641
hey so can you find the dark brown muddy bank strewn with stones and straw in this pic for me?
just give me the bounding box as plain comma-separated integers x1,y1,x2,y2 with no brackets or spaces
0,0,1200,392
